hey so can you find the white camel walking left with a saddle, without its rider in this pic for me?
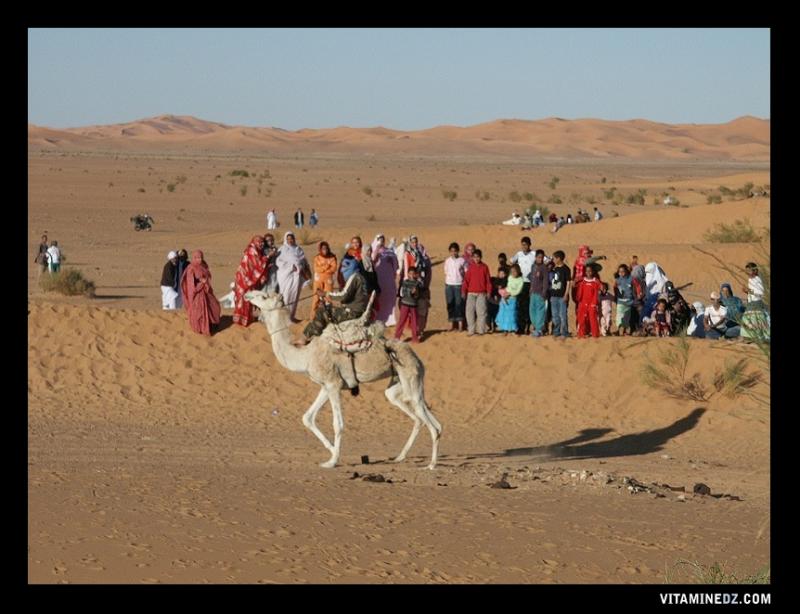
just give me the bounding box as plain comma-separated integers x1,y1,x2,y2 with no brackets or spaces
245,290,442,469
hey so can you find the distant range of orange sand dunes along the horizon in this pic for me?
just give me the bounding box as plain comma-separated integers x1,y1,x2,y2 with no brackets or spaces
28,115,770,161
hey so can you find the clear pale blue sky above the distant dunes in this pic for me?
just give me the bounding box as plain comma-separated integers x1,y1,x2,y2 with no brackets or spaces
28,28,770,130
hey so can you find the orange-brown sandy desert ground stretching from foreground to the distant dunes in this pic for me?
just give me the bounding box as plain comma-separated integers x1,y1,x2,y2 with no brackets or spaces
28,120,770,583
